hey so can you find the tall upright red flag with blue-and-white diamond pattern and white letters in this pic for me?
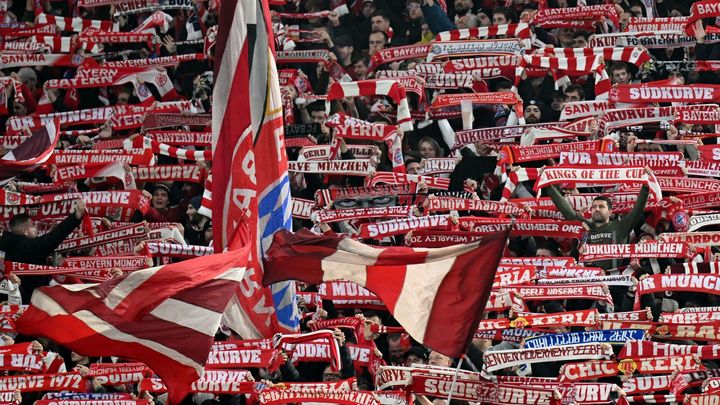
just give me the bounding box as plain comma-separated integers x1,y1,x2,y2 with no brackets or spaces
212,0,299,338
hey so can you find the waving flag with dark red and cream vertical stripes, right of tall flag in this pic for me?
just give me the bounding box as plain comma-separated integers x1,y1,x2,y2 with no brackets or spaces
263,230,510,358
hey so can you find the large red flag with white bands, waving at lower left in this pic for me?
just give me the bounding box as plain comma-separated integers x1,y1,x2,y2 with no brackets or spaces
17,241,249,403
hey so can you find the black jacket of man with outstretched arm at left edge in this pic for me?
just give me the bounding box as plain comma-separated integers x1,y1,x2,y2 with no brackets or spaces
0,213,80,302
